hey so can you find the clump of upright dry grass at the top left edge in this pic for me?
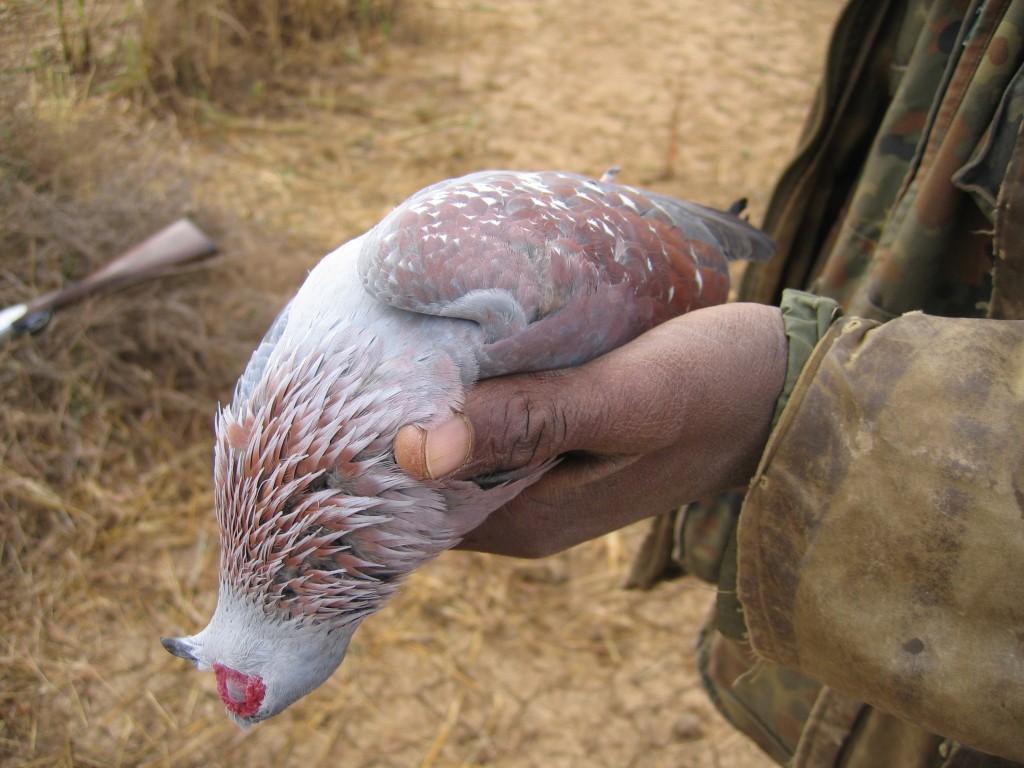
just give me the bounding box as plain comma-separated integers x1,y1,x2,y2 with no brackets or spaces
43,0,401,119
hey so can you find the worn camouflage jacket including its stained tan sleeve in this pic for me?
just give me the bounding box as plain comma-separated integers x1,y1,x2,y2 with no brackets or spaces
630,0,1024,767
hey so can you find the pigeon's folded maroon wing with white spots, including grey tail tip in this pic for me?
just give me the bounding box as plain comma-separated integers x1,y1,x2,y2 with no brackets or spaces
359,171,774,377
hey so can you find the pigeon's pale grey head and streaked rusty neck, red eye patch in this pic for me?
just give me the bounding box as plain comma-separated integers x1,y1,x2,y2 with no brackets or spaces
163,327,468,726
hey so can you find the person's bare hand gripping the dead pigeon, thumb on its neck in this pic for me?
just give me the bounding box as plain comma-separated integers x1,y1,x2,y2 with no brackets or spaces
395,303,787,557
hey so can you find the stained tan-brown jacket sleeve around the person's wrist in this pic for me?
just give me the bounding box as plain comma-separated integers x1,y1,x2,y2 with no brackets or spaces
737,313,1024,760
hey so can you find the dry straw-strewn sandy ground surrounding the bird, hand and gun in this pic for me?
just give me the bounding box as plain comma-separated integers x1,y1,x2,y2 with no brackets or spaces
0,0,836,768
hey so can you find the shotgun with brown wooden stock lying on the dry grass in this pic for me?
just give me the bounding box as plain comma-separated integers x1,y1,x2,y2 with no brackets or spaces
0,219,217,343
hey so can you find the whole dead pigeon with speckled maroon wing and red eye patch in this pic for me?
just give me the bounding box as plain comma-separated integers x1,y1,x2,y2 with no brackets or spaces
164,171,773,725
